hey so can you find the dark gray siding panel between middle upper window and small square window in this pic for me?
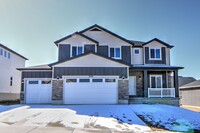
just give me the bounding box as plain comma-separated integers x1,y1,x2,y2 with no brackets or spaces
122,46,131,64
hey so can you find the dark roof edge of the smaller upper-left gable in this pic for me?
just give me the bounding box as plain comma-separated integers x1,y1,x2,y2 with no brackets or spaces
54,32,99,46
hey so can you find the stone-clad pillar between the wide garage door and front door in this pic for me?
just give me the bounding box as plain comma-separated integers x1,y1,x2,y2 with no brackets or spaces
118,80,129,104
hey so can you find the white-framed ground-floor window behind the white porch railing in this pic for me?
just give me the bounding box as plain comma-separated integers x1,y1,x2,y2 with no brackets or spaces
150,75,162,88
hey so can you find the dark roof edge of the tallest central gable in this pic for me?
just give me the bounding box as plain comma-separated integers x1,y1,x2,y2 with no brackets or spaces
80,24,134,45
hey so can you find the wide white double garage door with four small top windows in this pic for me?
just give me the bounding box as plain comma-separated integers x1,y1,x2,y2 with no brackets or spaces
63,77,118,104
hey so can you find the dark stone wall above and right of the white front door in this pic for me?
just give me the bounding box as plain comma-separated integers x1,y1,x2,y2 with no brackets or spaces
129,71,144,97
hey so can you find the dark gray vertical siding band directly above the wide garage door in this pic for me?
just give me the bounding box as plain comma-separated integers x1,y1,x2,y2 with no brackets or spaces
53,67,128,78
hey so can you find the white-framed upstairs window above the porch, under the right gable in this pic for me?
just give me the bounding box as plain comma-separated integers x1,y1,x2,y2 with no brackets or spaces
149,48,161,60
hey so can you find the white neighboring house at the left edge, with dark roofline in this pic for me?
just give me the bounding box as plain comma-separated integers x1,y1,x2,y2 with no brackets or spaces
0,44,27,101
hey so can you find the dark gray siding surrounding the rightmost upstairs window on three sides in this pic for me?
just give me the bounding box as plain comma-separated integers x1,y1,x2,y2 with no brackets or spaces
145,47,166,64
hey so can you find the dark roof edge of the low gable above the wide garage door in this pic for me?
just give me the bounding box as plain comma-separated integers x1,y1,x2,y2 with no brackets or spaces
49,52,131,67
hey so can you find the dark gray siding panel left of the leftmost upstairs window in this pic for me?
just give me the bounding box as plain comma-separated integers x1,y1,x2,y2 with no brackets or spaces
58,44,70,61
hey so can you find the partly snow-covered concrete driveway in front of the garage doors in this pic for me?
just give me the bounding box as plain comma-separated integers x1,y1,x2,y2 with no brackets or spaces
0,105,151,133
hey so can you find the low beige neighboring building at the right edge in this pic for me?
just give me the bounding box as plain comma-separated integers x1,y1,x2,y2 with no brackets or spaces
180,80,200,107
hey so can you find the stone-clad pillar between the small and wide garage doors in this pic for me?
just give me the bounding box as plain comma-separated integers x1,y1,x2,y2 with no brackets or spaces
52,79,63,104
